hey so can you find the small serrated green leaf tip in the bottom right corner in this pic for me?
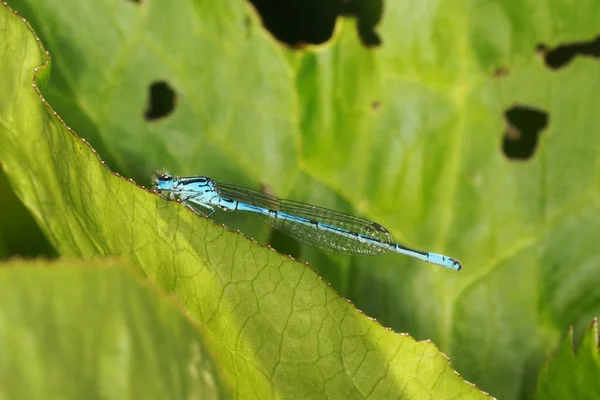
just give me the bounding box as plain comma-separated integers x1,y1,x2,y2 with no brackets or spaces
536,318,600,399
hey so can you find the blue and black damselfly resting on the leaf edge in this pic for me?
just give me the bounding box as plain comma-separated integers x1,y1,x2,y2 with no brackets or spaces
154,173,462,271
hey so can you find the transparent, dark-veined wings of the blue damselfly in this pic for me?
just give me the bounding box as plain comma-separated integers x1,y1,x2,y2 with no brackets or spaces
216,183,395,255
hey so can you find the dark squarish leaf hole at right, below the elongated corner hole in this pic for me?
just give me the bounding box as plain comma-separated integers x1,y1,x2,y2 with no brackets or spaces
502,106,548,160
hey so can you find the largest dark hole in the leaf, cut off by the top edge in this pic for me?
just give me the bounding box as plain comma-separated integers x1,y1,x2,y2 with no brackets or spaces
250,0,383,47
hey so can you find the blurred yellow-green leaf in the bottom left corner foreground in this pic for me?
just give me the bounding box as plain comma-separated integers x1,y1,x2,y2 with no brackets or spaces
0,260,231,400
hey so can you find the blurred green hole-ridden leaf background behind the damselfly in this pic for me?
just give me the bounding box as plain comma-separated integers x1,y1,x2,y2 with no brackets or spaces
0,0,600,399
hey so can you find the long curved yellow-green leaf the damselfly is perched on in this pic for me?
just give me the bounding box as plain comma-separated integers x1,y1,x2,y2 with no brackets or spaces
0,3,487,399
